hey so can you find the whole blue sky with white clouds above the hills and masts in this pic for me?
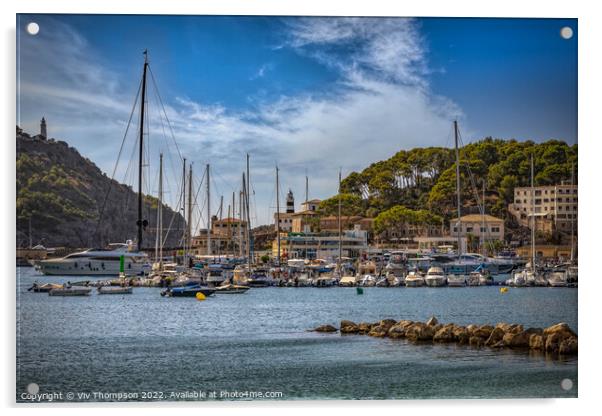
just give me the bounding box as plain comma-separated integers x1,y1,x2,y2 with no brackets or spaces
17,15,577,225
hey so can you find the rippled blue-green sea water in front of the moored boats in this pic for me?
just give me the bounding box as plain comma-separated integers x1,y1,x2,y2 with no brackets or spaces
16,268,577,401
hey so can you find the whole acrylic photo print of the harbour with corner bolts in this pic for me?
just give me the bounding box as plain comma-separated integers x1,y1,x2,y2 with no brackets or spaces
16,14,578,402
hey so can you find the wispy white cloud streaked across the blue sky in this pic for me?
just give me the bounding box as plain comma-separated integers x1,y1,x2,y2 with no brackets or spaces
20,18,461,223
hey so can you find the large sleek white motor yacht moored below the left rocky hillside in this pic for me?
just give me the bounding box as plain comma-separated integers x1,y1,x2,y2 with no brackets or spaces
37,241,151,276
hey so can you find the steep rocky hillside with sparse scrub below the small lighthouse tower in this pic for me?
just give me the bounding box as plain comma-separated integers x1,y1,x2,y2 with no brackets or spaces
16,133,184,248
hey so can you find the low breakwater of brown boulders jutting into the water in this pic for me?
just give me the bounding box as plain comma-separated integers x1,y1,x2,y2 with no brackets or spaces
314,317,577,355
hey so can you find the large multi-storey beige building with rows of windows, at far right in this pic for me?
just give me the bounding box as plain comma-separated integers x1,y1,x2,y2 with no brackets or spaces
508,184,578,233
